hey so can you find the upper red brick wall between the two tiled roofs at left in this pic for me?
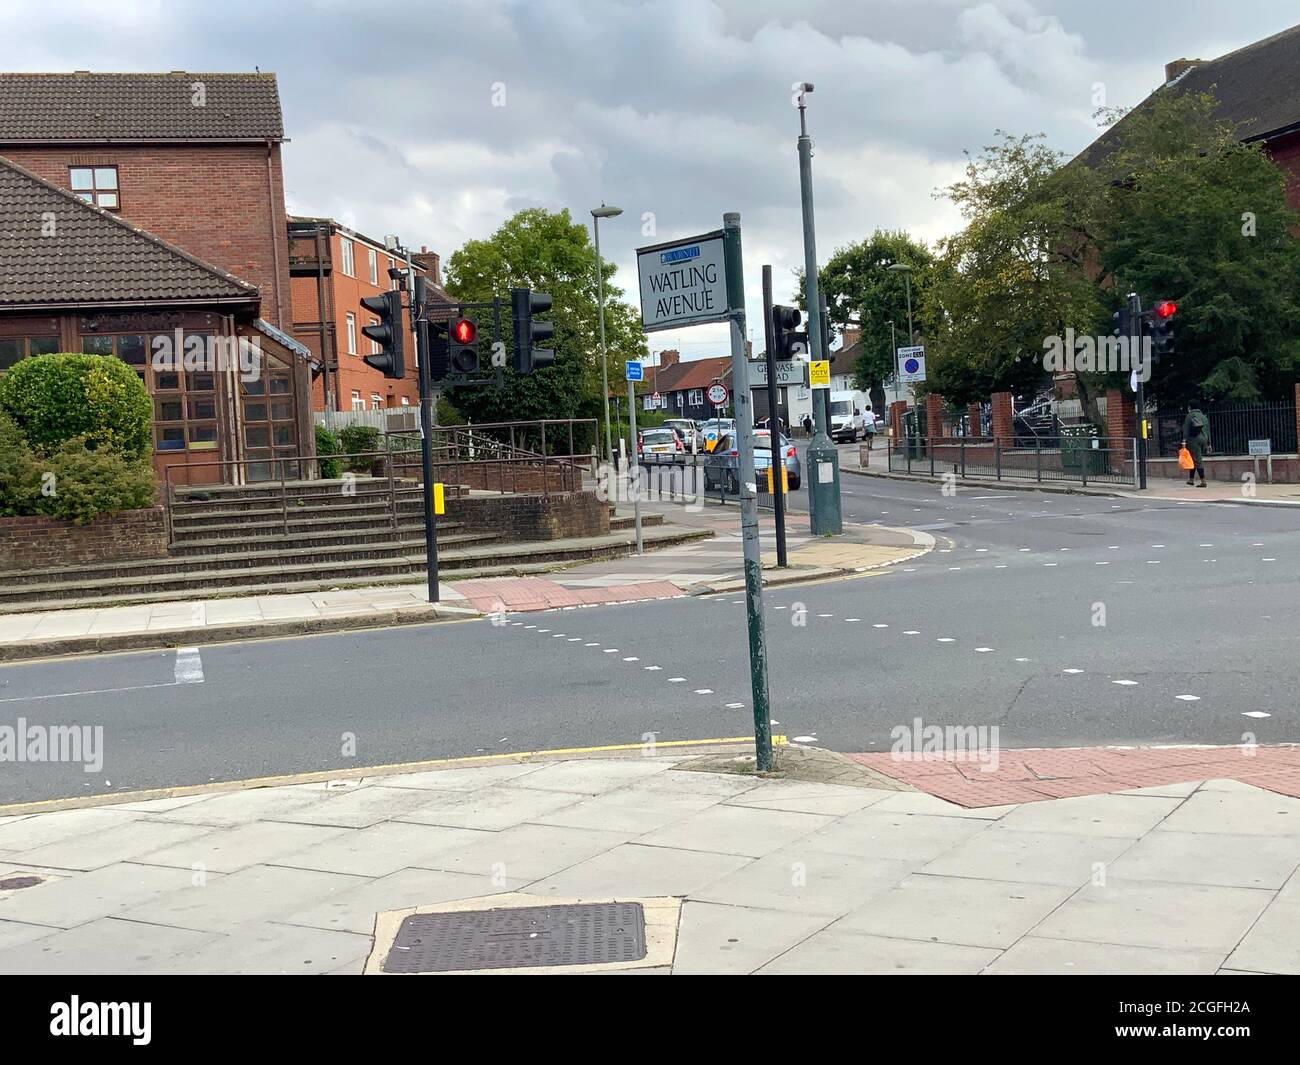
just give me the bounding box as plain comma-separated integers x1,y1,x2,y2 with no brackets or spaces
4,144,293,332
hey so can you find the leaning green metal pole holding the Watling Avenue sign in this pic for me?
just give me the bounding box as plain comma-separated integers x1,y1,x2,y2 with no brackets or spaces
723,212,775,772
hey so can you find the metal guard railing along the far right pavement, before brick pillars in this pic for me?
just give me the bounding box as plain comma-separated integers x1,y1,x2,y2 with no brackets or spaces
889,433,1138,485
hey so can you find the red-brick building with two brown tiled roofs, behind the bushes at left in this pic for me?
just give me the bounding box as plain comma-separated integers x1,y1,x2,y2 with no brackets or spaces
0,72,312,484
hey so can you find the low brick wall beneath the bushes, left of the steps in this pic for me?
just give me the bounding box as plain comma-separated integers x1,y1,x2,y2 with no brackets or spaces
0,507,166,570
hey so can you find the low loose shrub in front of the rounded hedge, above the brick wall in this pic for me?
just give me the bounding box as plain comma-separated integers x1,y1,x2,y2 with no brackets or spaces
29,437,157,525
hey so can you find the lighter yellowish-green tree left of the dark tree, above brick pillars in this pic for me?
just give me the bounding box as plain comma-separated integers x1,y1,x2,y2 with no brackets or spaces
926,131,1109,403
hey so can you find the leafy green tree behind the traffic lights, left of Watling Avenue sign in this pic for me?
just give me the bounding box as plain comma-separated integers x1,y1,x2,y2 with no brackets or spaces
446,207,647,446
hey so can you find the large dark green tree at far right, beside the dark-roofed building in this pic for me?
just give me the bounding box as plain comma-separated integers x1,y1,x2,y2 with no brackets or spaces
1096,92,1300,406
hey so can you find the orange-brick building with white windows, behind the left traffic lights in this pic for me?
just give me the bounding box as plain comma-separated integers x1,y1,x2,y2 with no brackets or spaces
289,216,446,411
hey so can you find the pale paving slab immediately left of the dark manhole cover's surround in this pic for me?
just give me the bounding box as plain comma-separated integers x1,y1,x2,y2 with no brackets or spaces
155,922,371,977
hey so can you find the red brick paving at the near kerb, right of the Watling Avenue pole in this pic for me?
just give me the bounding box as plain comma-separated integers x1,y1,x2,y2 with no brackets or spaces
849,744,1300,806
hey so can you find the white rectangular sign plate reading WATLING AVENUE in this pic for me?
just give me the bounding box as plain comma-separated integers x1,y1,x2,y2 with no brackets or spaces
637,230,729,333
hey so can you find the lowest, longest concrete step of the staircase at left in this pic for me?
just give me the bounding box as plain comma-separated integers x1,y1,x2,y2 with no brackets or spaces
0,525,712,614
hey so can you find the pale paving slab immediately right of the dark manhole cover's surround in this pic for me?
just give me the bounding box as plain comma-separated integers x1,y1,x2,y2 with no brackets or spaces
672,901,831,975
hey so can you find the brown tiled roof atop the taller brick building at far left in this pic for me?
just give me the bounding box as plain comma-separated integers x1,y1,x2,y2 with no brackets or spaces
0,70,285,144
